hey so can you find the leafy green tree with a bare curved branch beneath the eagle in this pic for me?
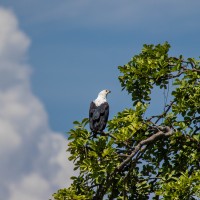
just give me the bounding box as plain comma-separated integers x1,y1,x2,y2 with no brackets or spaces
53,42,200,200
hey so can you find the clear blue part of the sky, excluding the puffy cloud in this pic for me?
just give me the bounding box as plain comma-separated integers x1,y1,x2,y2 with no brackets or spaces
3,0,200,132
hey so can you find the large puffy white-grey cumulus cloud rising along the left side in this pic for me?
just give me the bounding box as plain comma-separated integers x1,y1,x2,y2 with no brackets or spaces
0,8,73,200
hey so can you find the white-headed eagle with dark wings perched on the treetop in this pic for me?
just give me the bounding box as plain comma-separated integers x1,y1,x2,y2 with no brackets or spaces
89,90,111,133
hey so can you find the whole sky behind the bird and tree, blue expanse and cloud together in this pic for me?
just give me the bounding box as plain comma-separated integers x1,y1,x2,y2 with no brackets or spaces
0,0,200,200
